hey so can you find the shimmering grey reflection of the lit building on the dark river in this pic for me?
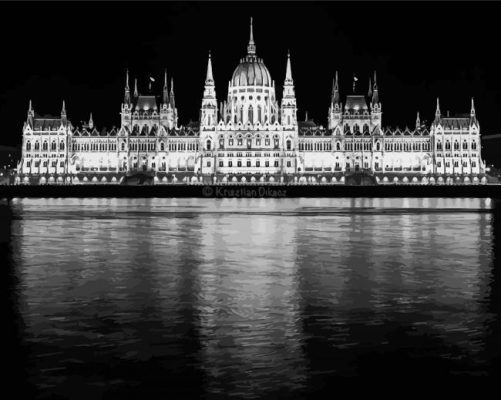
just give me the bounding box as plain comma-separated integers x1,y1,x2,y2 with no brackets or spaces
5,198,493,398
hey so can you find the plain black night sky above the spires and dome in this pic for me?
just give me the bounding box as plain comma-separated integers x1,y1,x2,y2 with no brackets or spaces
0,2,501,152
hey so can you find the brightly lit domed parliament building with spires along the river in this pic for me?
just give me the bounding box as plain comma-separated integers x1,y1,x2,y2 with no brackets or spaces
16,20,485,184
